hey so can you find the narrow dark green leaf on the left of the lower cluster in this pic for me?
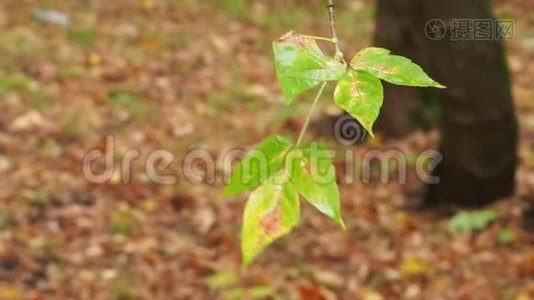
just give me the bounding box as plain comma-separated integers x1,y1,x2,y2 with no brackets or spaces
222,136,293,197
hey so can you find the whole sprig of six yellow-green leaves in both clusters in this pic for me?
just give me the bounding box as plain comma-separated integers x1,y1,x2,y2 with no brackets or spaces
223,32,443,264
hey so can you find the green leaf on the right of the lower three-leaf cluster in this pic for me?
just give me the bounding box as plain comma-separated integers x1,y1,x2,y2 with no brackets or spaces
286,143,345,228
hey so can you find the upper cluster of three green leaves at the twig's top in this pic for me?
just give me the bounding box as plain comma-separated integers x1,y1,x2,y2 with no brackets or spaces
274,32,444,135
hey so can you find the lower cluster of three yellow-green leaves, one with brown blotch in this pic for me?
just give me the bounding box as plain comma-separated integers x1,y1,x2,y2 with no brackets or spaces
223,136,344,264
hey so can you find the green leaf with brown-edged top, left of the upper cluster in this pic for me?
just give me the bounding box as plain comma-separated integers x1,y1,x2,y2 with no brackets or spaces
273,32,347,104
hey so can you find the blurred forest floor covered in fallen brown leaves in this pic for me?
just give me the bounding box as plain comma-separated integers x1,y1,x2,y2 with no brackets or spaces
0,0,534,300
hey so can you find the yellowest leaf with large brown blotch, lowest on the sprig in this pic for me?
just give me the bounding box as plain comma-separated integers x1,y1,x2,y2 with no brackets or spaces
241,177,300,265
